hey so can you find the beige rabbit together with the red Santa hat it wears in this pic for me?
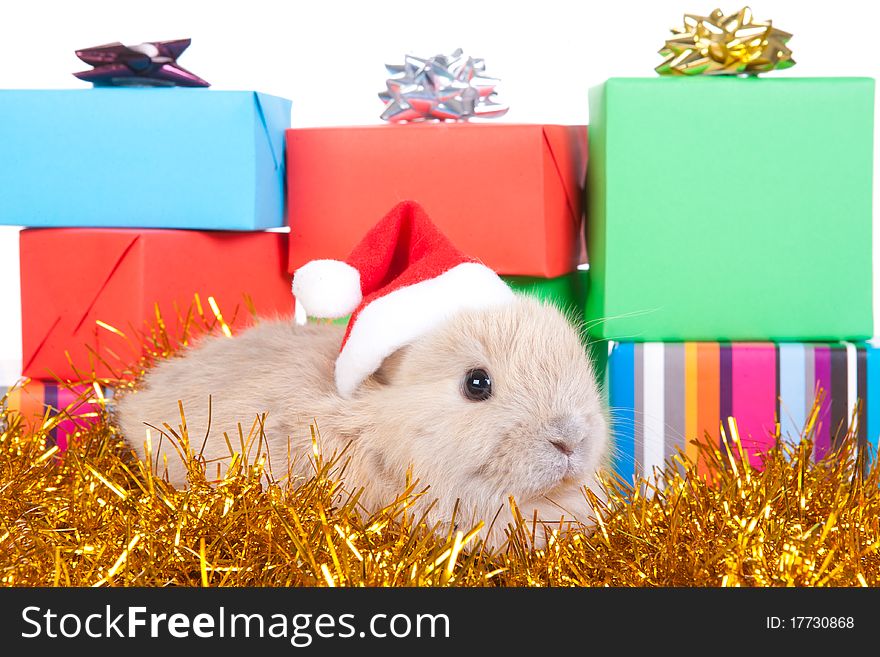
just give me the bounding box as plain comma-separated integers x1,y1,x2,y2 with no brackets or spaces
118,202,608,544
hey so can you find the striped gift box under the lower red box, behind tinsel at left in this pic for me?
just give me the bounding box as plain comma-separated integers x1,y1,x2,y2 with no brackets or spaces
0,380,112,451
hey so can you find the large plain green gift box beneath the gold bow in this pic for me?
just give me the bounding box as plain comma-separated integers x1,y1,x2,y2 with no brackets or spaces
586,76,874,341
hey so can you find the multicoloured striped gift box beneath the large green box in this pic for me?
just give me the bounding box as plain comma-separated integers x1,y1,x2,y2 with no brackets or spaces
606,342,880,479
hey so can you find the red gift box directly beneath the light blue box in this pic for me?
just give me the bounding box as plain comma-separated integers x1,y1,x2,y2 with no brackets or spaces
20,228,293,379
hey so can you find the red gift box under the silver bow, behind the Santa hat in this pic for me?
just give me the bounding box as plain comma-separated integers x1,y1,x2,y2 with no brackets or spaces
287,123,587,278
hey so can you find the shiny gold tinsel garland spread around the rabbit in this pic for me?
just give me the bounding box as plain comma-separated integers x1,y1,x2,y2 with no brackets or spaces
0,304,880,586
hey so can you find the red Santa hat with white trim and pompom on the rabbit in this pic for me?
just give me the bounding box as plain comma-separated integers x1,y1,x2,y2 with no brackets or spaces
293,201,514,397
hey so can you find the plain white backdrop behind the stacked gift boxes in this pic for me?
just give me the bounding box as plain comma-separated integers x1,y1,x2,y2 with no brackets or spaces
0,0,880,385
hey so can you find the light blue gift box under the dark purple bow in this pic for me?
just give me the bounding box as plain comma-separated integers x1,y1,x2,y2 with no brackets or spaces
0,88,290,230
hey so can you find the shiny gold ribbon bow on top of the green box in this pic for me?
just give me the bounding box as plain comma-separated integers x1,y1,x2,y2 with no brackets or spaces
655,7,795,75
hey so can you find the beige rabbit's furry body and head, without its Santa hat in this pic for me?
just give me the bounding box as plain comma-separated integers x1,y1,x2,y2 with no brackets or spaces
117,297,608,544
